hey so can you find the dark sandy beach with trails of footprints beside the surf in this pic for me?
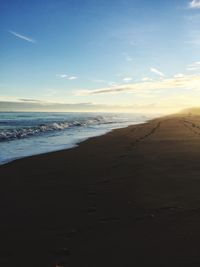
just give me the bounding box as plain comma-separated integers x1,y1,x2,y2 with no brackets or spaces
0,115,200,267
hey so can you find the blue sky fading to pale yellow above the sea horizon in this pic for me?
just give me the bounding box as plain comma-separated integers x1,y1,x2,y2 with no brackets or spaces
0,0,200,113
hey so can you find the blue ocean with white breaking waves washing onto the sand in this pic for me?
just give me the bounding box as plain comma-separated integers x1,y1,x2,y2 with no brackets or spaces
0,112,152,164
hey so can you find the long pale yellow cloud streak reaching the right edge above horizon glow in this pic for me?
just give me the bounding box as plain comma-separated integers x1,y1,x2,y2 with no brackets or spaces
76,75,200,96
